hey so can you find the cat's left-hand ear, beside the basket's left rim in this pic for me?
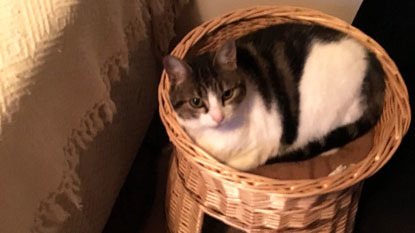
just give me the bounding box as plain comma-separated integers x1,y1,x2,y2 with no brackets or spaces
163,55,191,86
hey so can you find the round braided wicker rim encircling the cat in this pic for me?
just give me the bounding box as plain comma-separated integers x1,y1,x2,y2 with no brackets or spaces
159,5,411,197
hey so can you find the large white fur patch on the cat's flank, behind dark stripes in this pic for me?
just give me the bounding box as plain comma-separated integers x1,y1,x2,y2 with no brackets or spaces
290,38,367,149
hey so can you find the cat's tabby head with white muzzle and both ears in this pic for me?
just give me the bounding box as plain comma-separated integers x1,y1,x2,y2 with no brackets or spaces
163,41,246,129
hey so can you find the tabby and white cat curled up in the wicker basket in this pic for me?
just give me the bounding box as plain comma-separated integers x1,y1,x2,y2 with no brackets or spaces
163,23,385,170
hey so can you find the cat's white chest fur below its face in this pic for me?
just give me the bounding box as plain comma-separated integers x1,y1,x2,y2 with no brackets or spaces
190,90,282,170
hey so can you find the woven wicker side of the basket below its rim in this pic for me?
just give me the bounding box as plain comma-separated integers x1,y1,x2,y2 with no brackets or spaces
166,148,368,233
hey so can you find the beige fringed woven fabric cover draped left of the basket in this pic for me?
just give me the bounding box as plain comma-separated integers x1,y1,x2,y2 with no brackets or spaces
0,0,186,233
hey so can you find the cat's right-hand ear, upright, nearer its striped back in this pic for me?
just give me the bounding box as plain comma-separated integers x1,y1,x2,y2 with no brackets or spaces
214,40,236,70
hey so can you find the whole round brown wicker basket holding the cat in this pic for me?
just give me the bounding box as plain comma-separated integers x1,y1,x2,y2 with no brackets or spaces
159,6,410,233
